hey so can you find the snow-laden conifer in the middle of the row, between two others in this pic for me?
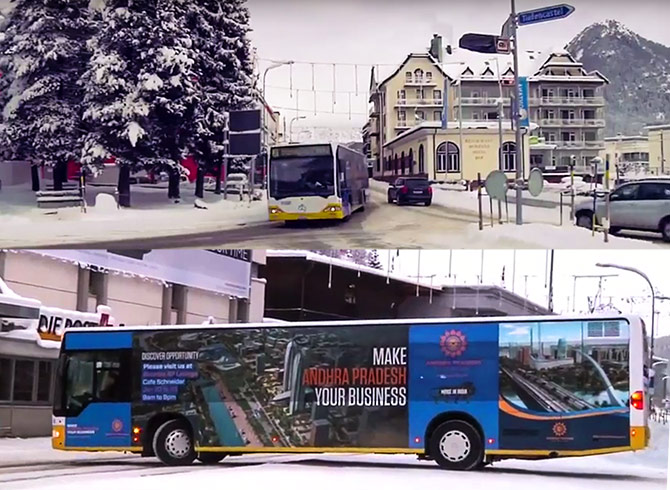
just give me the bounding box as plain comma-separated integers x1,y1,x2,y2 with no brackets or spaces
82,0,199,206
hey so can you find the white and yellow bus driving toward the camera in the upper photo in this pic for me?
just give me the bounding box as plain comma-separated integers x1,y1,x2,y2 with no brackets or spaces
268,143,370,221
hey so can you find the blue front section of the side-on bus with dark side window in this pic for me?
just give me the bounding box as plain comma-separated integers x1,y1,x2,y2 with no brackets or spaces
53,333,133,448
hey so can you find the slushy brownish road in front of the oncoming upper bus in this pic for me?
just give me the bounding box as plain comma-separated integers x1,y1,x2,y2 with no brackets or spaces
56,190,488,250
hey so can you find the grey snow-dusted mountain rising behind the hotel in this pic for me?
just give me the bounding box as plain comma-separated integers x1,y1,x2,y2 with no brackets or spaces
566,20,670,136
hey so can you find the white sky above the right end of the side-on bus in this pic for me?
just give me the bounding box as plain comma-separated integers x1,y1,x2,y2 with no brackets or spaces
379,250,670,336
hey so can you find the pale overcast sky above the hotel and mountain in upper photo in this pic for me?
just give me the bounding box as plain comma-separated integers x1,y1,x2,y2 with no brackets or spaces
248,0,670,127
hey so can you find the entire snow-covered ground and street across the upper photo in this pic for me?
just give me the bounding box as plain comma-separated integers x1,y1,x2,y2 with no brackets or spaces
5,181,668,249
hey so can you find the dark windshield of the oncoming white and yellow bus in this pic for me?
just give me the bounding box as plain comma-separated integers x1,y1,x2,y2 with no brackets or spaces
270,156,335,199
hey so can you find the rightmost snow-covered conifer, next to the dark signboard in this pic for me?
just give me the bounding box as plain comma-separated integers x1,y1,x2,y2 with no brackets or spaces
185,0,255,197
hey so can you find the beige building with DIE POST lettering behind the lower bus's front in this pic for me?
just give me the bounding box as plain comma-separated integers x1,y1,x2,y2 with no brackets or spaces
0,250,265,437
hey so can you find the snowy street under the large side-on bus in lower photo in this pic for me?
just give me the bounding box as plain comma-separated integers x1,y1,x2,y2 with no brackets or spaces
0,425,668,490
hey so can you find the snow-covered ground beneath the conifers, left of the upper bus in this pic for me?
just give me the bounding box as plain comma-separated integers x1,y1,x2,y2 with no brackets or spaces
0,185,268,248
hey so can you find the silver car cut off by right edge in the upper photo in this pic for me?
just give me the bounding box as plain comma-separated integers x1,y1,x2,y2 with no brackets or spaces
575,178,670,241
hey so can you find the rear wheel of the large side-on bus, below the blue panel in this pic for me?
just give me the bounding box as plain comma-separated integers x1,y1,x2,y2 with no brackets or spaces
430,420,484,471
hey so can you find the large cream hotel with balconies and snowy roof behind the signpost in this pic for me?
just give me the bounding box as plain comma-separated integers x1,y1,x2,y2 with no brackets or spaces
364,36,609,177
